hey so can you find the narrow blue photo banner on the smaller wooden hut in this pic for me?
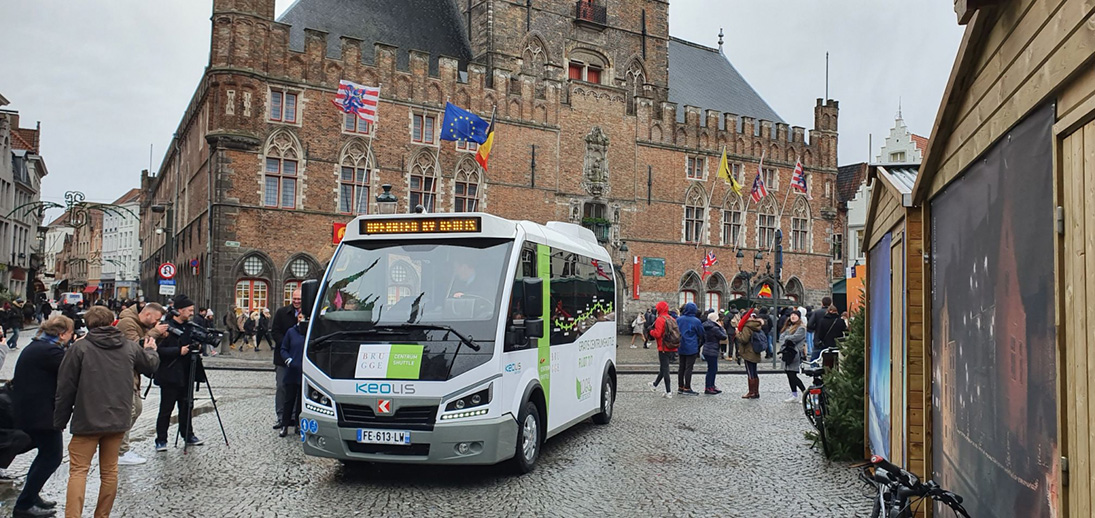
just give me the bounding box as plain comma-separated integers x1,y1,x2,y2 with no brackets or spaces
867,232,894,459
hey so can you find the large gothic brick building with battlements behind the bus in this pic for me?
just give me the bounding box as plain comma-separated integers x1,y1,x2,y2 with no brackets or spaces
140,0,843,313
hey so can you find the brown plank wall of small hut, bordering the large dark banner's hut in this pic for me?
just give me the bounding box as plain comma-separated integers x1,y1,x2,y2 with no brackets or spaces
904,207,932,480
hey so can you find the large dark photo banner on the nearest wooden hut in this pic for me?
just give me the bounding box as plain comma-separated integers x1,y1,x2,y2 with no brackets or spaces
931,105,1060,518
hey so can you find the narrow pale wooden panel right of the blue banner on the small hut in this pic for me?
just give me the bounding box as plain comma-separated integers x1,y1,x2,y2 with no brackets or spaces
890,232,909,469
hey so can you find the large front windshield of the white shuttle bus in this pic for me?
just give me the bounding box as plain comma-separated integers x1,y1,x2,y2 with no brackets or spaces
308,239,512,380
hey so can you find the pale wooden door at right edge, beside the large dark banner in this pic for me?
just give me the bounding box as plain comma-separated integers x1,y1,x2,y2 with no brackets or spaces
1058,122,1095,517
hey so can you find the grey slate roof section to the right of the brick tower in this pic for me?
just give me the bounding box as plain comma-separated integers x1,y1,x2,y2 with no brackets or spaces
669,37,783,128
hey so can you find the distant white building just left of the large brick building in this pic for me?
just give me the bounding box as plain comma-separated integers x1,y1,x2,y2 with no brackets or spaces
100,188,140,299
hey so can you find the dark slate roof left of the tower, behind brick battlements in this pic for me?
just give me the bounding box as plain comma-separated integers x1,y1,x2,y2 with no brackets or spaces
277,0,472,76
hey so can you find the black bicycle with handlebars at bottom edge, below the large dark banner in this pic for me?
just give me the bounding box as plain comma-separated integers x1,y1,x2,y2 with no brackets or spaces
860,456,969,518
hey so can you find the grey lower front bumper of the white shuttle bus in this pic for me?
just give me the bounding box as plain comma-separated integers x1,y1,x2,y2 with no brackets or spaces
303,414,517,464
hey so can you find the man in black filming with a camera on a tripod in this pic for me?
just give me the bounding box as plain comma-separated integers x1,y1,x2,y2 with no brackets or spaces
155,295,205,451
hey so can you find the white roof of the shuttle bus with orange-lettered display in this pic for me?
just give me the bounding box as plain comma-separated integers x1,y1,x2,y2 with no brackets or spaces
343,212,612,263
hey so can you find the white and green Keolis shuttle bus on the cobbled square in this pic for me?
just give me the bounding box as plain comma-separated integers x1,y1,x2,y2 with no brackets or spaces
301,212,616,473
